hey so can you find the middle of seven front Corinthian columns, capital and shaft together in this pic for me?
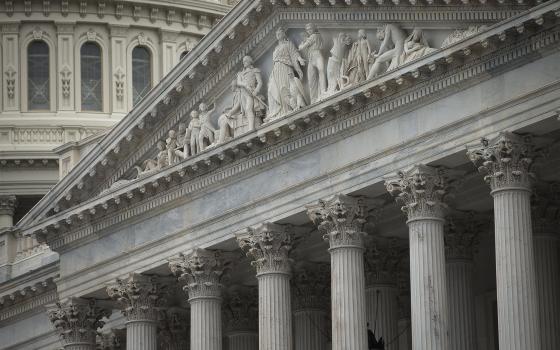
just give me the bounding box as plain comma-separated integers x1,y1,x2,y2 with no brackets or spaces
237,222,293,350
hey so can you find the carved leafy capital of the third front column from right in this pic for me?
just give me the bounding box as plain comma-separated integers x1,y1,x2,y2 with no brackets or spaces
307,194,382,249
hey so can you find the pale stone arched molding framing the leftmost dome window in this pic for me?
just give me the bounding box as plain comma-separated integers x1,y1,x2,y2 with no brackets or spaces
19,29,58,112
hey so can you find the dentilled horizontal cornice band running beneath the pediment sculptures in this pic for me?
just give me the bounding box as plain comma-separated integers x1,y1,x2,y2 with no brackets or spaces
26,15,560,251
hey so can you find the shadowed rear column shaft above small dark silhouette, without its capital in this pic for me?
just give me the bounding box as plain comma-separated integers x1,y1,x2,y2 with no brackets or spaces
366,284,399,350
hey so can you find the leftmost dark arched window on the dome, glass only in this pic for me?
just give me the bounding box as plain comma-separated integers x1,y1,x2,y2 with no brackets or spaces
27,40,50,110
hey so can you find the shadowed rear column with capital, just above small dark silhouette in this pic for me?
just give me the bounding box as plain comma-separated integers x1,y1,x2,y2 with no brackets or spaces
365,239,403,350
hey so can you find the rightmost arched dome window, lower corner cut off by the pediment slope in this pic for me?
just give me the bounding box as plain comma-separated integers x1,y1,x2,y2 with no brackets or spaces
132,46,152,104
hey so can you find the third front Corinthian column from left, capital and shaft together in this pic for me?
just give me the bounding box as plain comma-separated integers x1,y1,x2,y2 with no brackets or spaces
169,249,224,350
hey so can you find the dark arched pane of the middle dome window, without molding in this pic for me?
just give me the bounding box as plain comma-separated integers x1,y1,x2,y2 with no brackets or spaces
80,42,103,111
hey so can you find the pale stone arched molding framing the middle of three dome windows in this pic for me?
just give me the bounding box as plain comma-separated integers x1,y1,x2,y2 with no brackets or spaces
73,32,111,113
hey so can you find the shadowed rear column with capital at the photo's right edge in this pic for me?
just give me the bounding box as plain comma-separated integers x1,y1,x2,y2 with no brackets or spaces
531,183,560,350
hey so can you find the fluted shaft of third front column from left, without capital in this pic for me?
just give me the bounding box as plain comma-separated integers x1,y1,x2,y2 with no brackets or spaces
189,297,222,350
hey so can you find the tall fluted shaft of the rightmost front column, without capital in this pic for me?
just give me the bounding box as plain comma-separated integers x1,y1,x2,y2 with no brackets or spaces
492,189,542,350
